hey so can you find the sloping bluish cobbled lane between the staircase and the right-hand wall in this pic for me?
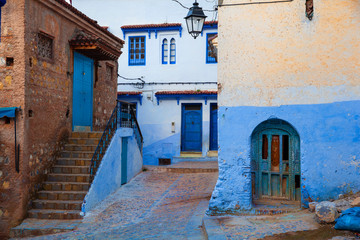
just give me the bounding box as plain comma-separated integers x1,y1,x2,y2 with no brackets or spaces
23,171,217,240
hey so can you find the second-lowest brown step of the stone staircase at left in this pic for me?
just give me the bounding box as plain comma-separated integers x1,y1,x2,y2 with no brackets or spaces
32,199,83,211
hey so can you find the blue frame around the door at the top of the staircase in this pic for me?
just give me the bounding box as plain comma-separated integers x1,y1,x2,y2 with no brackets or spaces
72,51,94,131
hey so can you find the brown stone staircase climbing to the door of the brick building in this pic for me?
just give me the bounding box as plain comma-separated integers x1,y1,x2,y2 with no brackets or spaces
28,132,102,219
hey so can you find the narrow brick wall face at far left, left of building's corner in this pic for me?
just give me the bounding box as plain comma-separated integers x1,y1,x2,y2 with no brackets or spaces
0,0,28,239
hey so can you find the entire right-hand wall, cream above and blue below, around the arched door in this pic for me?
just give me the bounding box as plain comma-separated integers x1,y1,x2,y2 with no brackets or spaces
209,0,360,213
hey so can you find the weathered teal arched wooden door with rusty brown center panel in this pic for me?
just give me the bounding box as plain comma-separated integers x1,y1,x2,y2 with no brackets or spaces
251,119,301,201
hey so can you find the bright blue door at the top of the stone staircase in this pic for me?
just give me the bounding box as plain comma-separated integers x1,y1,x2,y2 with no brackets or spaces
73,52,94,131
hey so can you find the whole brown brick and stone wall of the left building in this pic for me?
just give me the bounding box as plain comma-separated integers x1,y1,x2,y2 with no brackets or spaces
0,0,121,238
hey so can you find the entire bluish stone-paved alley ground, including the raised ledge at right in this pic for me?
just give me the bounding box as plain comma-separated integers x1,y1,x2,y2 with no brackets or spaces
9,162,356,240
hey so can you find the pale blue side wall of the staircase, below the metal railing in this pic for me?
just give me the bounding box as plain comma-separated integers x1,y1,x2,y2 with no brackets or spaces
82,128,143,213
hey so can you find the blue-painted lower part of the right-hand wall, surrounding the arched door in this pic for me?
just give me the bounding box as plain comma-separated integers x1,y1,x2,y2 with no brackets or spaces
209,101,360,212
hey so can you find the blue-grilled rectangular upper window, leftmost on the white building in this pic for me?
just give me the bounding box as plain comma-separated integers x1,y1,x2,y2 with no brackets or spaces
129,36,146,66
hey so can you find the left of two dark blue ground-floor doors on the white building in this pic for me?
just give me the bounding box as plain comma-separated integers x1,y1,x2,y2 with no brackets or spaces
181,104,202,152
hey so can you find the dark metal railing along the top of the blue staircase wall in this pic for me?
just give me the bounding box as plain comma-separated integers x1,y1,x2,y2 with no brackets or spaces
90,100,143,184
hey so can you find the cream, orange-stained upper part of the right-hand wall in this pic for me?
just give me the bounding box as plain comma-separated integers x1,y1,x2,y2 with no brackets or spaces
218,0,360,106
